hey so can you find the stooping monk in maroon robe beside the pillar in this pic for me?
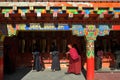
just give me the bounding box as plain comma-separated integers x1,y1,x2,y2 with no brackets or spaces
65,44,81,75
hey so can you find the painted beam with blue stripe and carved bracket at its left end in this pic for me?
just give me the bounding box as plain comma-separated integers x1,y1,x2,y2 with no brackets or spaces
7,23,70,36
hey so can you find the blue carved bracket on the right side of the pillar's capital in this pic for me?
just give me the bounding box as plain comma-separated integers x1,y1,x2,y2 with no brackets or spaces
98,25,110,36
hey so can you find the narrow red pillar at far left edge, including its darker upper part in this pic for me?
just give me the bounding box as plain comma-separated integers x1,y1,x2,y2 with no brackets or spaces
0,42,4,80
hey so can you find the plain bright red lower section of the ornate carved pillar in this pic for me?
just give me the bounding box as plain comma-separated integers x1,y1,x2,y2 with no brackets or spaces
86,57,94,80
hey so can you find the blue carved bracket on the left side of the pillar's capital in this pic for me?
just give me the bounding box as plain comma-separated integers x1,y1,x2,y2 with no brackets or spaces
72,24,84,36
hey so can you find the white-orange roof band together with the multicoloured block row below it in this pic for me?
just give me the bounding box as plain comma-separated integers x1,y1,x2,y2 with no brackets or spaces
0,2,120,14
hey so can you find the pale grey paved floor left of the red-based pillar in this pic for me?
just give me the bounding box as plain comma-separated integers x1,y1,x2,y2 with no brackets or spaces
4,68,85,80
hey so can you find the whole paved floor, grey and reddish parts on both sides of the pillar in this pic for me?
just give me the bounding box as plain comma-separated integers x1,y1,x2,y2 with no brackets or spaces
4,68,120,80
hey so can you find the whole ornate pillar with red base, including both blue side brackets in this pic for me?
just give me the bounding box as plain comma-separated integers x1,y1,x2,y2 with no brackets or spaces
72,25,110,80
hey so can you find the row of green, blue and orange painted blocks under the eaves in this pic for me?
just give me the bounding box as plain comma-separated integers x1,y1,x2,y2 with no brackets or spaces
2,8,120,15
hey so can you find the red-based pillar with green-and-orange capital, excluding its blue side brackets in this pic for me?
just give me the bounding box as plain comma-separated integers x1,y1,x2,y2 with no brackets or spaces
84,25,98,80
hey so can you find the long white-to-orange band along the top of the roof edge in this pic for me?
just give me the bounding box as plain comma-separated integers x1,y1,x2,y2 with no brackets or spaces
0,2,120,7
